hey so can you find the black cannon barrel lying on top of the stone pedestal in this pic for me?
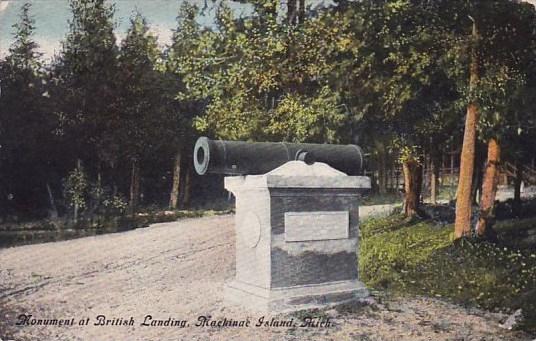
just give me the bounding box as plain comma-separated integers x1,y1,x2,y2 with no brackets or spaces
194,137,364,175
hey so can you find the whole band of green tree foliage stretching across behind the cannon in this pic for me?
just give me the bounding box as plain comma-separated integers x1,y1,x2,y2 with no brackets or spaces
0,0,536,228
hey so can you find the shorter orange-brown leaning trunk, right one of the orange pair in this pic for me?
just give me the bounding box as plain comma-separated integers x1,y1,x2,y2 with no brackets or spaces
476,138,501,236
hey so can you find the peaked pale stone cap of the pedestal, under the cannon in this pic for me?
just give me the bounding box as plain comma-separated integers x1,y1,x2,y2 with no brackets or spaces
225,161,371,192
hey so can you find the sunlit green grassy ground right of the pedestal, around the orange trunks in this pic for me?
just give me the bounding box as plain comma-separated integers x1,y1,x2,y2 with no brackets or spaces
359,215,536,333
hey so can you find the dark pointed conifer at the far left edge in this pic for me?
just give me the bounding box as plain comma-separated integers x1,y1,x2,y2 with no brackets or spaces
0,3,57,217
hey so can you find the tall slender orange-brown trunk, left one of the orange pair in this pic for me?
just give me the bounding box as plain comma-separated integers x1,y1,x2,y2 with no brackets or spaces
454,22,478,238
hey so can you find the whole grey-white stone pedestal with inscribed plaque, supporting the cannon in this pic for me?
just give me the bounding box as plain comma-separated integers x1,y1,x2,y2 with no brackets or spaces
224,161,370,312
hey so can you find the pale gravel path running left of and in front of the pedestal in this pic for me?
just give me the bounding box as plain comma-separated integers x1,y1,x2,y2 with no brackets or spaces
0,215,529,341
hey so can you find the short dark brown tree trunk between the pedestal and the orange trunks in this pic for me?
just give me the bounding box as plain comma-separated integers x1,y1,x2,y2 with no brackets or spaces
402,160,422,217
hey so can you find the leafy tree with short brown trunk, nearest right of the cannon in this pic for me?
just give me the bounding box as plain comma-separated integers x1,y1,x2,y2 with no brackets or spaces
336,1,458,216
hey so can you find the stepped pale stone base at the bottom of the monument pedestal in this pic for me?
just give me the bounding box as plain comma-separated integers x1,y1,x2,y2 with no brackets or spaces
224,280,369,313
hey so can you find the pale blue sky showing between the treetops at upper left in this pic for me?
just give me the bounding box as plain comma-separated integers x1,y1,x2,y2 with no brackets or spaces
0,0,253,57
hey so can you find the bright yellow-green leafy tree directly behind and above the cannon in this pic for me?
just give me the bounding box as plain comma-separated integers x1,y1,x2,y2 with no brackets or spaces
191,0,354,142
